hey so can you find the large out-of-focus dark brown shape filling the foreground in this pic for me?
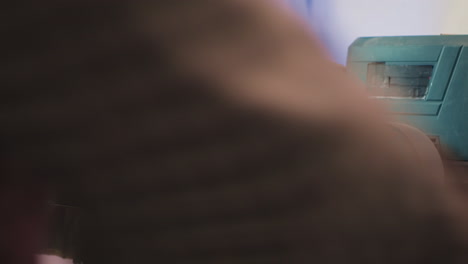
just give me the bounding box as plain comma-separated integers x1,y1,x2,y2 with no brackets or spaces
0,0,468,264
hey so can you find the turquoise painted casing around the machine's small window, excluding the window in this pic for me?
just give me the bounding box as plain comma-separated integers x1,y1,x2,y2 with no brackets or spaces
347,35,468,161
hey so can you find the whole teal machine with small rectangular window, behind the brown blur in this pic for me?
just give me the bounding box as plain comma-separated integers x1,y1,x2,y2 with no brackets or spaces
347,35,468,162
